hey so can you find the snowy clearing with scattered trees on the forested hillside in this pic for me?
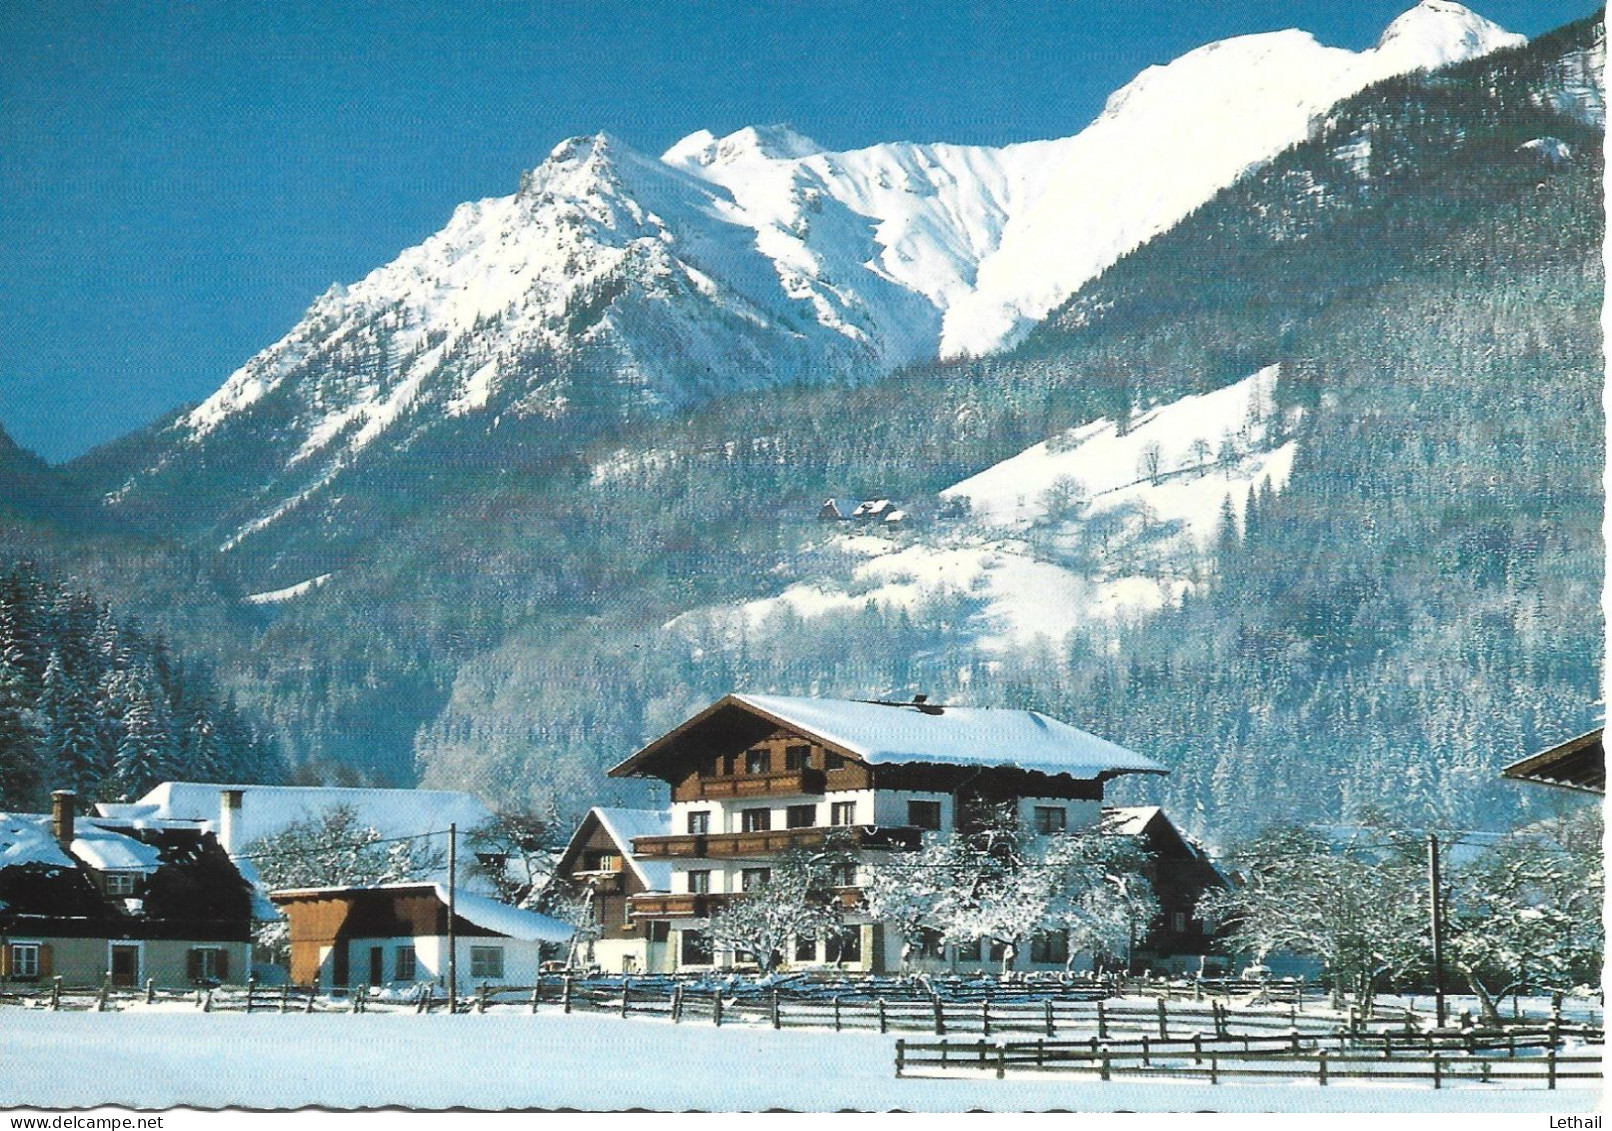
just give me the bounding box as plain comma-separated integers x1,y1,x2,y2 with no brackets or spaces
669,366,1299,653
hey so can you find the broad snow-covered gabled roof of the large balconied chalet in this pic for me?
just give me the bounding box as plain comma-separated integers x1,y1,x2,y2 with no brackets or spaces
611,694,1169,780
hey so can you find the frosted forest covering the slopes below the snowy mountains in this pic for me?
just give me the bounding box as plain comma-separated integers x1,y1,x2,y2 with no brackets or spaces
0,16,1604,839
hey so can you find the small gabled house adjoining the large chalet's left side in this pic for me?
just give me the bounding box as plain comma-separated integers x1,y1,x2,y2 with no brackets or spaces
556,806,675,973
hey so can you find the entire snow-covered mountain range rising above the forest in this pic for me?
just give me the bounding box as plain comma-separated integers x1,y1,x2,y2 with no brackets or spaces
108,0,1517,551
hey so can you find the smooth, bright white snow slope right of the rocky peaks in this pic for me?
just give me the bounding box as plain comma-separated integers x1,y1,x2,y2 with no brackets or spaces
940,0,1523,356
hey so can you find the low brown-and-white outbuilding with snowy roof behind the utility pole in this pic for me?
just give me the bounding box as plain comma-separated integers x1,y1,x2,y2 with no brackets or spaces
269,883,574,989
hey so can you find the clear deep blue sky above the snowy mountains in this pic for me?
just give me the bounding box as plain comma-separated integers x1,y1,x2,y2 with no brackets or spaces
0,0,1594,459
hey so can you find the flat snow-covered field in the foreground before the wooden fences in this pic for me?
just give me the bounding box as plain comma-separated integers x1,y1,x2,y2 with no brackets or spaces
0,1010,1601,1126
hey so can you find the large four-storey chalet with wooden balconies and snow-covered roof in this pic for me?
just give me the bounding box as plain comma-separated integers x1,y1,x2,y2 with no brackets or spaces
611,694,1186,972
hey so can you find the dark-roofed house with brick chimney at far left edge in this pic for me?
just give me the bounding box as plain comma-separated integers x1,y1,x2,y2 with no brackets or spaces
0,791,253,986
